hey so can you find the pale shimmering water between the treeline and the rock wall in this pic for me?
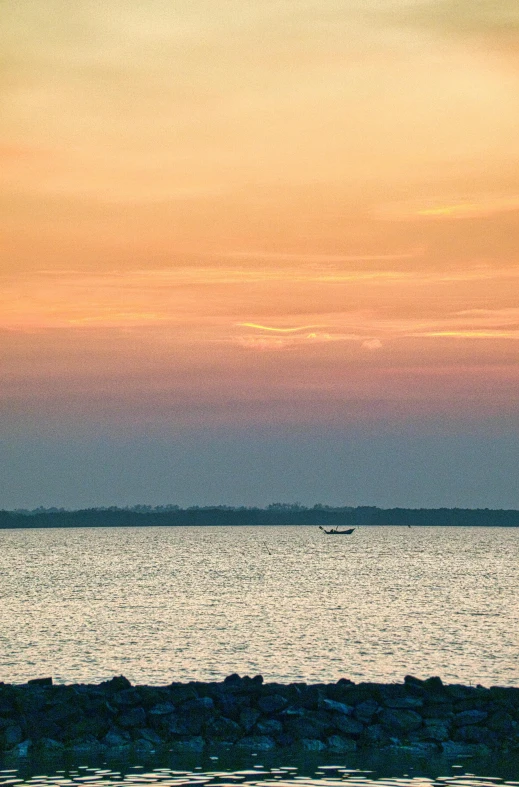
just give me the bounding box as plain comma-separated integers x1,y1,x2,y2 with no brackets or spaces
0,527,519,688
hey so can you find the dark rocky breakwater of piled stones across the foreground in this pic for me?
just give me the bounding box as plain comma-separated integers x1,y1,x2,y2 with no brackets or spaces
0,675,519,756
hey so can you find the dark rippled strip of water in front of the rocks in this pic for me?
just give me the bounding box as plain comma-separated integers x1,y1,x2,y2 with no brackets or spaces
0,755,519,787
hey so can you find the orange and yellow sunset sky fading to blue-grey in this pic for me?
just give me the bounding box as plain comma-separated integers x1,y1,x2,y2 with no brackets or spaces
0,0,519,508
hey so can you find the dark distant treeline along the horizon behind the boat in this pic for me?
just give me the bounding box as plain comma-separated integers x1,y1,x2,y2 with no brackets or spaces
0,503,519,529
